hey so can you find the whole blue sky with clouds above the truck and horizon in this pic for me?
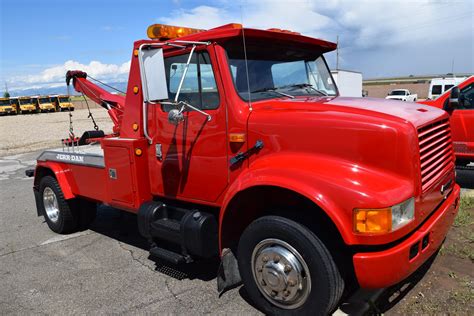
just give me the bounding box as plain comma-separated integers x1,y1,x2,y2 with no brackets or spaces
0,0,474,91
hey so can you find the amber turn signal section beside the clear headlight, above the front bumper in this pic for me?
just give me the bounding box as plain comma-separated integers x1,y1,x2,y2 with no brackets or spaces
354,208,392,234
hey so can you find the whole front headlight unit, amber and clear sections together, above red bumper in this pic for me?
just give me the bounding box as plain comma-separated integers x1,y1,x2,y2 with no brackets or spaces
354,198,415,234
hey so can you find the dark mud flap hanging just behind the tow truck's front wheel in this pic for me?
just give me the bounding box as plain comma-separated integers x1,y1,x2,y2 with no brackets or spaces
217,248,242,297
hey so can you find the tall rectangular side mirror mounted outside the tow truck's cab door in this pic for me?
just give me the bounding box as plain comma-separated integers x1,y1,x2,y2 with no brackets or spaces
139,47,168,102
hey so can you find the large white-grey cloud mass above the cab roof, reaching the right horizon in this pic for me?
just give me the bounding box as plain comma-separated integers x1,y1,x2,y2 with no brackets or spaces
157,0,474,75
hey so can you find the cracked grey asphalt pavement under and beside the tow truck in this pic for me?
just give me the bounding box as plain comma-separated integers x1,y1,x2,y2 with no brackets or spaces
0,152,474,315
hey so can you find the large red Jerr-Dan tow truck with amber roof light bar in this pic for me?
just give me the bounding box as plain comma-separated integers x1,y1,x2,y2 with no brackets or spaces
34,24,460,314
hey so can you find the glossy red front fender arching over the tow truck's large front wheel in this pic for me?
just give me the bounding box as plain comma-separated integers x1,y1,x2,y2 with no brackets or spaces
219,153,414,245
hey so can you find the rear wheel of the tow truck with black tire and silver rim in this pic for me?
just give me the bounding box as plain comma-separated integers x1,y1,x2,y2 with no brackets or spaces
39,176,79,234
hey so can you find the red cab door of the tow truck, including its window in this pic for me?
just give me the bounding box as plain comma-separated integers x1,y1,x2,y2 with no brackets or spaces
148,50,228,202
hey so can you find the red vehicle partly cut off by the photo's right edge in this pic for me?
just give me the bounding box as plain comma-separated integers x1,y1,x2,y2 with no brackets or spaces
419,76,474,167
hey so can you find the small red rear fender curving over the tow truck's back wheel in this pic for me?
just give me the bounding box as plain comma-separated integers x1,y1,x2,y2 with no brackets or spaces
34,161,76,200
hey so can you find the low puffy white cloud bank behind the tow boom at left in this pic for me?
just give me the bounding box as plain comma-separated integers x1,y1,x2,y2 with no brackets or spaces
8,60,130,90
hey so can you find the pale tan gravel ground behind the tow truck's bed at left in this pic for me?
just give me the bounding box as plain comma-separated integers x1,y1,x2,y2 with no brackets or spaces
0,109,113,157
